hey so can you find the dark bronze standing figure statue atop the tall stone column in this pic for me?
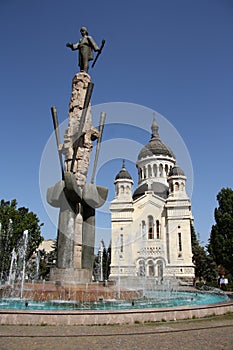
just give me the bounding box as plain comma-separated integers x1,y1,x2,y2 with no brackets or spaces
66,27,100,73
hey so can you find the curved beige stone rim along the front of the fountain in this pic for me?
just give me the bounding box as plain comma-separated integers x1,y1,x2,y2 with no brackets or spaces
0,301,233,325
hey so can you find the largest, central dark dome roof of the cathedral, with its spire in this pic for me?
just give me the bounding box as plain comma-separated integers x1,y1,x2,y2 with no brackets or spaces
138,120,175,161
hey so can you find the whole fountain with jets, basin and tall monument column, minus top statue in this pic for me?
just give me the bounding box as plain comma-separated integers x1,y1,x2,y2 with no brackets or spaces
0,29,233,325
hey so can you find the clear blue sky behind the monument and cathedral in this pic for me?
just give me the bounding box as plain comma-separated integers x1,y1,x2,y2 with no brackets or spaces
0,0,233,245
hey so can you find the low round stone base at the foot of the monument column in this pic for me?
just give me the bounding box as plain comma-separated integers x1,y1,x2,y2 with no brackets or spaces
50,268,92,285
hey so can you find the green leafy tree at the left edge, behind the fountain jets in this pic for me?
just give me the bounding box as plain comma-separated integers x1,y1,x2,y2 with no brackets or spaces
0,199,43,281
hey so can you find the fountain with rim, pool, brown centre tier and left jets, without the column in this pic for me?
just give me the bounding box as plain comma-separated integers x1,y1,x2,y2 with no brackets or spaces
0,239,233,324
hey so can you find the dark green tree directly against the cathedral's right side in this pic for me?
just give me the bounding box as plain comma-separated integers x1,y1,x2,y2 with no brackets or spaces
191,226,217,283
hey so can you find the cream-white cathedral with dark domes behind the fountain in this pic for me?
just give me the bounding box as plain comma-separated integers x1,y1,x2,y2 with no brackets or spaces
110,120,194,285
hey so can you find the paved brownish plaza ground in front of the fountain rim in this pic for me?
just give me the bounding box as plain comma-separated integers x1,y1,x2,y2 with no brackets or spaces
0,314,233,350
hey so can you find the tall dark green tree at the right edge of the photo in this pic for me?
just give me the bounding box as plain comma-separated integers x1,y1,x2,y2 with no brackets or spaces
208,188,233,275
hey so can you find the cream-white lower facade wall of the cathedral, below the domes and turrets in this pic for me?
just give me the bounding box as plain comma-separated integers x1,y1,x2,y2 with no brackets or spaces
110,192,194,281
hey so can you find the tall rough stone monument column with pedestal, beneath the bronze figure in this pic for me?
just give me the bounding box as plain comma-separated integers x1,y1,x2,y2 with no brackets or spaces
47,72,108,284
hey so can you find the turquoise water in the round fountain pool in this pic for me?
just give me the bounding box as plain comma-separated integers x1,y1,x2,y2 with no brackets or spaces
0,291,229,310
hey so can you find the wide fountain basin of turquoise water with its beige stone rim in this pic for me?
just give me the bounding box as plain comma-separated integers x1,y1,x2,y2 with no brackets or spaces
0,286,233,325
